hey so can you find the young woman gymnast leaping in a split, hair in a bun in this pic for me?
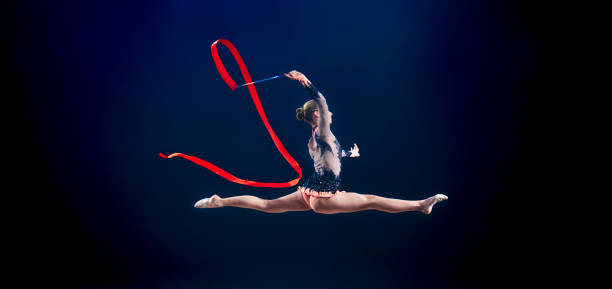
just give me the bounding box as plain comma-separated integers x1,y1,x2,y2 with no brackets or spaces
195,70,447,214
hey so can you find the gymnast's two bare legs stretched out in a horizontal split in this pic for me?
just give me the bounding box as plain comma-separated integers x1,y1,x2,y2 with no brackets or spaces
195,191,448,214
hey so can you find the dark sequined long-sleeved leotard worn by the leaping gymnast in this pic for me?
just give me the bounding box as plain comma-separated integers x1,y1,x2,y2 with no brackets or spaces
299,84,348,197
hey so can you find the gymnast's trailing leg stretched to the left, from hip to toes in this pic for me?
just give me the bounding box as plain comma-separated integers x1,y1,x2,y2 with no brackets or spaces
194,191,310,213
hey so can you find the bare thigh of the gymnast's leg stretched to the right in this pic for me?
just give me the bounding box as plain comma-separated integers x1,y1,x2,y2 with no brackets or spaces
312,192,369,213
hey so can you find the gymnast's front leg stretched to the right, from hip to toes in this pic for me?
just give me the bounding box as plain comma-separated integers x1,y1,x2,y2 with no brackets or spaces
312,193,448,214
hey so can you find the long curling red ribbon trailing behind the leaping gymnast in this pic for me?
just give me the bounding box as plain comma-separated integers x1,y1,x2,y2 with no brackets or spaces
159,39,302,188
